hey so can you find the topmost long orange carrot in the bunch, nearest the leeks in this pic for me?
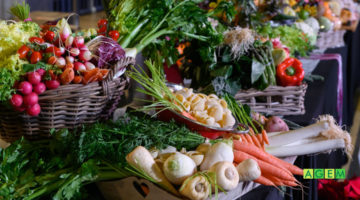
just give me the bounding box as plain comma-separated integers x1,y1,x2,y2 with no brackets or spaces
233,141,303,175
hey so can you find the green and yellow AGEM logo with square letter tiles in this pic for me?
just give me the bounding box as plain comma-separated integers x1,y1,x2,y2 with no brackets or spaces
304,169,346,179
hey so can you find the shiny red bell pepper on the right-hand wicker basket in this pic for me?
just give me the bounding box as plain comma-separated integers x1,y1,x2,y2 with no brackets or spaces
276,58,305,86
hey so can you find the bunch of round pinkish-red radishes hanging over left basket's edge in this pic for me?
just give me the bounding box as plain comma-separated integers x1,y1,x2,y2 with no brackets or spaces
10,69,60,116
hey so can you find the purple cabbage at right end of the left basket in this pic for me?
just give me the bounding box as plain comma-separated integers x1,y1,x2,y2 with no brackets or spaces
96,37,125,68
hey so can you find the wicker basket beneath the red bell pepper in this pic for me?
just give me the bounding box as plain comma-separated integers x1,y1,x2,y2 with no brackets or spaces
235,84,307,115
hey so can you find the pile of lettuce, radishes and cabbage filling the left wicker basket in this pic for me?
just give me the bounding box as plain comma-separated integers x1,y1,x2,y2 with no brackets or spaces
0,4,125,116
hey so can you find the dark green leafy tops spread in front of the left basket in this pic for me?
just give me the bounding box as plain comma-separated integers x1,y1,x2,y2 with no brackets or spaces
0,115,204,199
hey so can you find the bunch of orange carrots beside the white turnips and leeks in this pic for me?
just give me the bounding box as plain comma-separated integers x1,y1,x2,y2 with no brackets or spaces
233,139,303,187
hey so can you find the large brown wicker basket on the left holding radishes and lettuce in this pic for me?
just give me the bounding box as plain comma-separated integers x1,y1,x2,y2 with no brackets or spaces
0,58,135,142
